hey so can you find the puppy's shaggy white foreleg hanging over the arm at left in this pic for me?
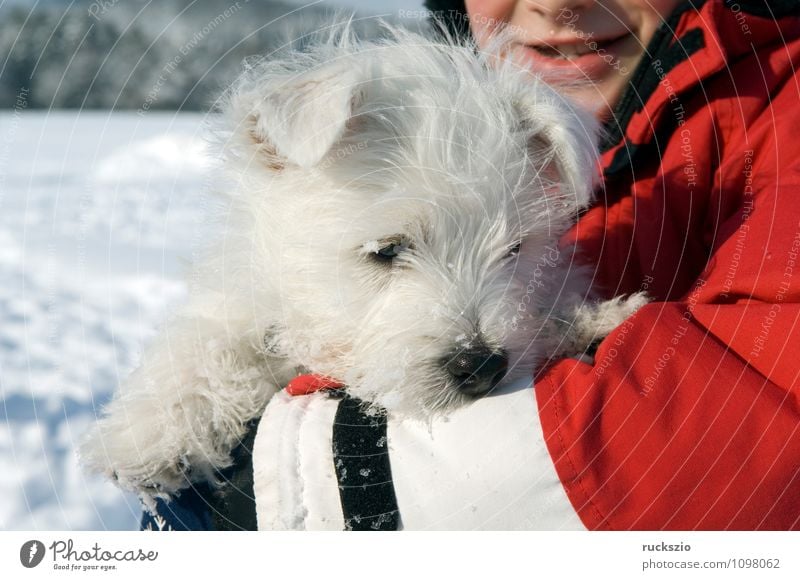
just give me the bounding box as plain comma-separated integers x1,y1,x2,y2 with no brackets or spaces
81,297,293,503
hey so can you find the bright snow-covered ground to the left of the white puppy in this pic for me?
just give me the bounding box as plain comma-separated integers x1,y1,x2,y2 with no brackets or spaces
0,110,220,530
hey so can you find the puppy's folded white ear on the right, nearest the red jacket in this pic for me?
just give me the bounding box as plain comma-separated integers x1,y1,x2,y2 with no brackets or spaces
514,81,600,209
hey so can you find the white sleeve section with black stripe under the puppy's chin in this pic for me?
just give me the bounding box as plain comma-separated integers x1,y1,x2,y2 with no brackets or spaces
253,379,585,530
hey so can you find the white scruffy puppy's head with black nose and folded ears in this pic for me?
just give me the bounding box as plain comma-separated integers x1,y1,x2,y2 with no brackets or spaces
216,31,596,413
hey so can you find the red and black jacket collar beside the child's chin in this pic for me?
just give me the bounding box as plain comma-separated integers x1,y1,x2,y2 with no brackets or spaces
601,0,800,177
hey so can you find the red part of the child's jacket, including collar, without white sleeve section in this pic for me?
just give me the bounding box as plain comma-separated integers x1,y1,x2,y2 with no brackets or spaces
536,0,800,530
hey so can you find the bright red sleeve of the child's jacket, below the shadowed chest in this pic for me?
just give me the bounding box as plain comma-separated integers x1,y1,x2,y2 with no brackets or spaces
536,79,800,530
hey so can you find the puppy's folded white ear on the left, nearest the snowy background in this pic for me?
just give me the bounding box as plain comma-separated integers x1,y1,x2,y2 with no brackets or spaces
239,59,367,169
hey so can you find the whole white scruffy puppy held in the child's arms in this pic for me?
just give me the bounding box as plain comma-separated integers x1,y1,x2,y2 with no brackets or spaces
81,26,646,502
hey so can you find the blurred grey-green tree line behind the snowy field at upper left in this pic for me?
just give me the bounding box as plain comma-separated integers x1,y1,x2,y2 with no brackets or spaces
0,0,396,110
